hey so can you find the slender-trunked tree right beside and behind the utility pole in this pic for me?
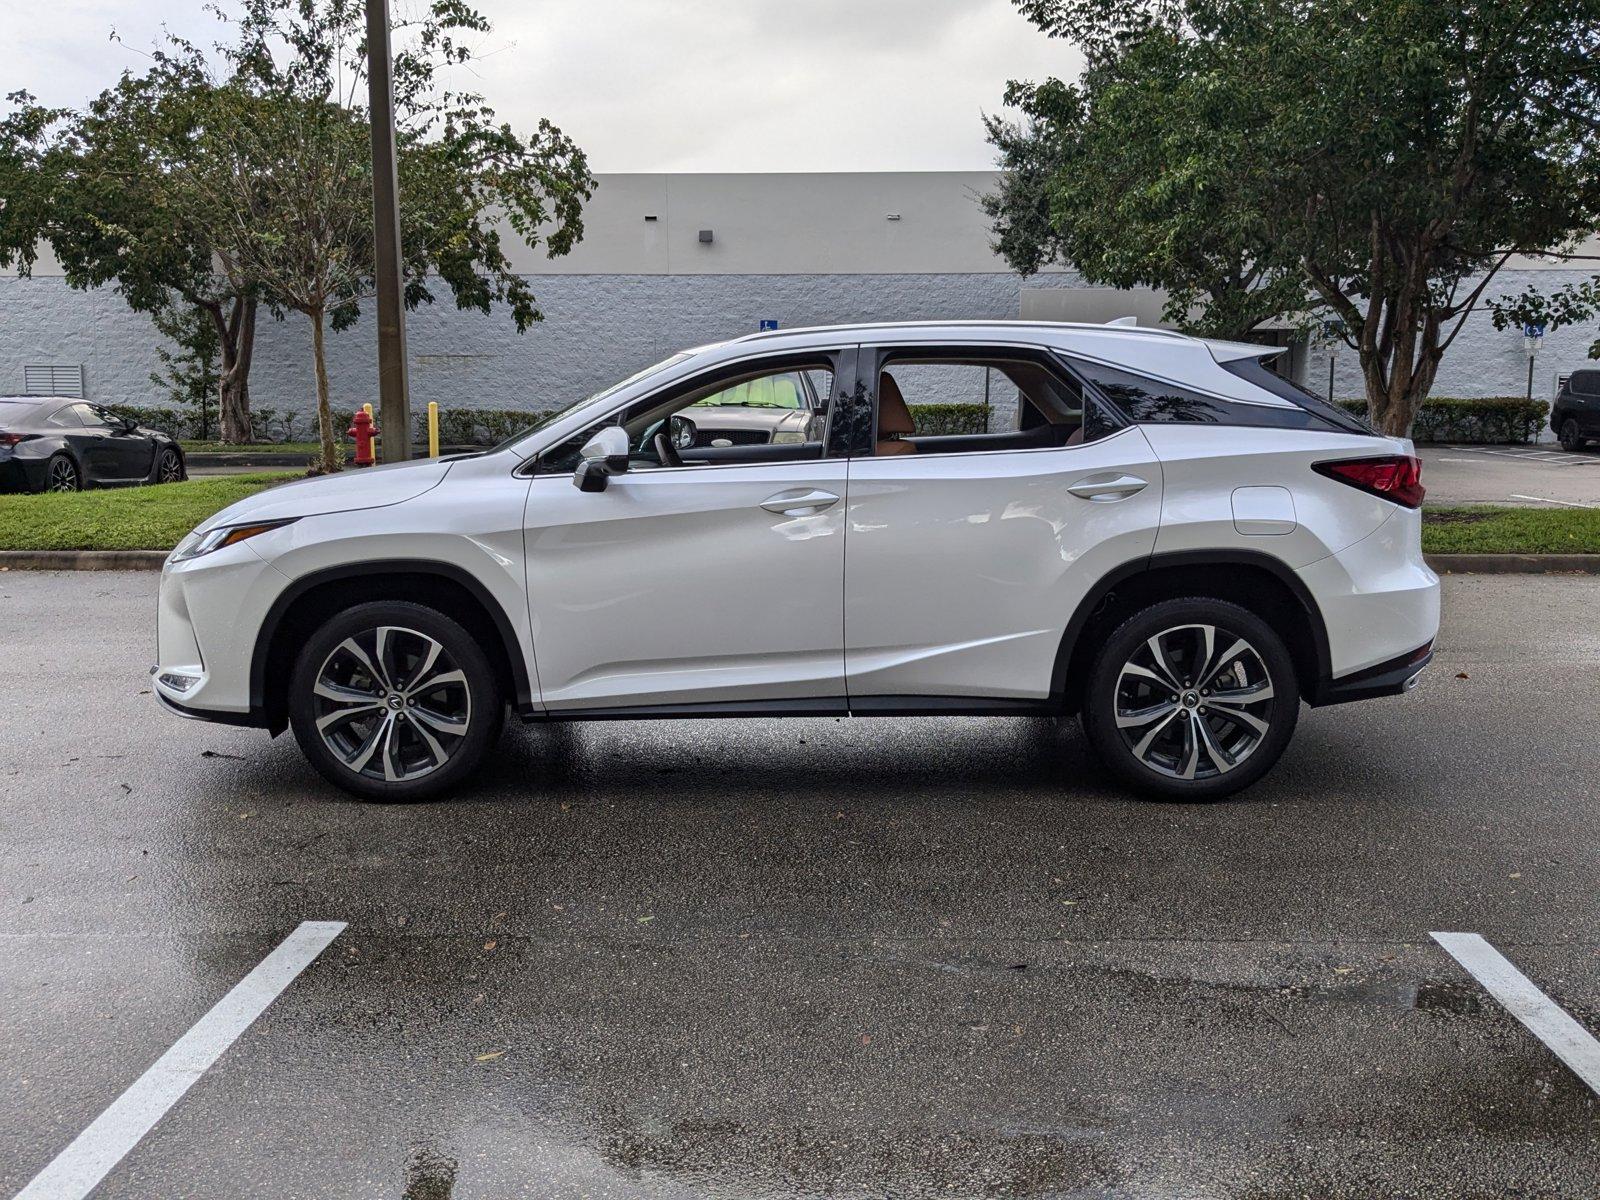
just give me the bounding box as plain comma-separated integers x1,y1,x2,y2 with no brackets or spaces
179,0,594,470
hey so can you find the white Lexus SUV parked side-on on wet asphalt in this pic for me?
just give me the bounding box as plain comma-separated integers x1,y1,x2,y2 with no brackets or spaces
152,322,1438,800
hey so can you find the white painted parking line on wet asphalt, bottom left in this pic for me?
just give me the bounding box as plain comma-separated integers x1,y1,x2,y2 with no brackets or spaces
16,922,344,1200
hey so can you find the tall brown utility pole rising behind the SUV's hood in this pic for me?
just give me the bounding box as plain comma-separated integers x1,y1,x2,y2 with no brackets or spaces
366,0,411,462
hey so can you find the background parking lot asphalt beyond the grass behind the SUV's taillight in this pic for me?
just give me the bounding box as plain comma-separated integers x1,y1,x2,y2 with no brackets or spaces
1418,445,1600,509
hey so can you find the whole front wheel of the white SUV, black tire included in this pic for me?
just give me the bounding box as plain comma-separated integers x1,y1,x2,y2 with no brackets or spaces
288,600,506,803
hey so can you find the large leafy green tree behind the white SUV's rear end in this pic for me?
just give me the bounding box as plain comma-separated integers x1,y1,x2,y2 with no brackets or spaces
992,0,1600,434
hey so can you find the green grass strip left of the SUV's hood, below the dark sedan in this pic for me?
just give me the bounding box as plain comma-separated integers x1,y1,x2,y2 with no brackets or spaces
0,472,299,550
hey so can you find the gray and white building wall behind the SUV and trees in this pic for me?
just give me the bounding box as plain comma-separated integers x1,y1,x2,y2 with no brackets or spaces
0,171,1594,432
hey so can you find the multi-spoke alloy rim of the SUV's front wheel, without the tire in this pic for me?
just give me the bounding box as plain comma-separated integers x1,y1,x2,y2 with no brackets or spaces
312,626,472,782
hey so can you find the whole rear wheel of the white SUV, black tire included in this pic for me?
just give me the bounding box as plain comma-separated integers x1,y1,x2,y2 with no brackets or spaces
1080,597,1299,802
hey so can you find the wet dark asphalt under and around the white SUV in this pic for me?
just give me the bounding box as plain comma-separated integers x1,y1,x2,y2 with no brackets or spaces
0,573,1600,1200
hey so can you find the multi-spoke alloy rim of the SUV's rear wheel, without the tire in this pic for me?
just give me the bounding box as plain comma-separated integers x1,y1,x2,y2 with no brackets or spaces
1115,624,1274,779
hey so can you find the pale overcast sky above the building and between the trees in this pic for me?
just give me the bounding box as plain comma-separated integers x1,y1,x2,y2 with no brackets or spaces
0,0,1078,171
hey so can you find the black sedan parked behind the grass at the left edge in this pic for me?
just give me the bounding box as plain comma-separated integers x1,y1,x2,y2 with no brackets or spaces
0,395,189,491
